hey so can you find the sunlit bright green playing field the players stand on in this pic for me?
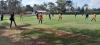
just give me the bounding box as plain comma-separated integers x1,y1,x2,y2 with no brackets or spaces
1,15,100,30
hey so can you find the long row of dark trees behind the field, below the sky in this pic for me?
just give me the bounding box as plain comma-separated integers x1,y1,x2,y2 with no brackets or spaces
0,0,100,13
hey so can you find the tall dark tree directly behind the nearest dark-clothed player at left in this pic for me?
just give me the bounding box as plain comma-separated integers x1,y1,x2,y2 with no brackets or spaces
7,0,22,13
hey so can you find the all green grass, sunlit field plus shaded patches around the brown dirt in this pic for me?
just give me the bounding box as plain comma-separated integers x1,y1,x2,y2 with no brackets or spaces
0,15,100,45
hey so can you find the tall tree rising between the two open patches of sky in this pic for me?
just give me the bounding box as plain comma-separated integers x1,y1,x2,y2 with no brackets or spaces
56,0,73,13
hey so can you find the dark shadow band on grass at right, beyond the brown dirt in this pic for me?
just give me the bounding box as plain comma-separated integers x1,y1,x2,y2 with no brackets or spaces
57,27,100,37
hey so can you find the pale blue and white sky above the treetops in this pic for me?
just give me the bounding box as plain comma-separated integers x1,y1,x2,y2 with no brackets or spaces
22,0,100,8
